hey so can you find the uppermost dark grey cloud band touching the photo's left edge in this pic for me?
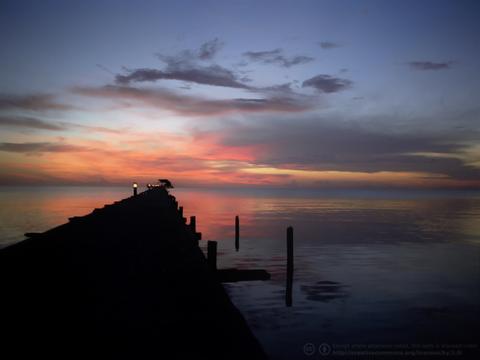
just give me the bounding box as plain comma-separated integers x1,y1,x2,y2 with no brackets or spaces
0,94,73,111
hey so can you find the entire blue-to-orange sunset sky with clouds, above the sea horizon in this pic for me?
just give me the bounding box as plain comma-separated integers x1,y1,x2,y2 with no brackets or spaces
0,0,480,189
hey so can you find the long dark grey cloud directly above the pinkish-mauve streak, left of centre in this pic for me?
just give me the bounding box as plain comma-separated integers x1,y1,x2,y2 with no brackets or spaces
115,64,249,89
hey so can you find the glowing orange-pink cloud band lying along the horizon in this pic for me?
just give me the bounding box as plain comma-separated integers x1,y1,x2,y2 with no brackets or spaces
0,117,480,187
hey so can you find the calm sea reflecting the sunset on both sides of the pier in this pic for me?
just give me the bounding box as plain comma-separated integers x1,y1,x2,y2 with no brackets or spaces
0,187,480,359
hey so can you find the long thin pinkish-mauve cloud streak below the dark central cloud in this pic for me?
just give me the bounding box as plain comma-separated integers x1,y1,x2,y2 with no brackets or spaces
73,85,312,116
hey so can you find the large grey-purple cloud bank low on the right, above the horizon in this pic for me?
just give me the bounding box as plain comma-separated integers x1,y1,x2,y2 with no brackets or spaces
200,117,480,180
